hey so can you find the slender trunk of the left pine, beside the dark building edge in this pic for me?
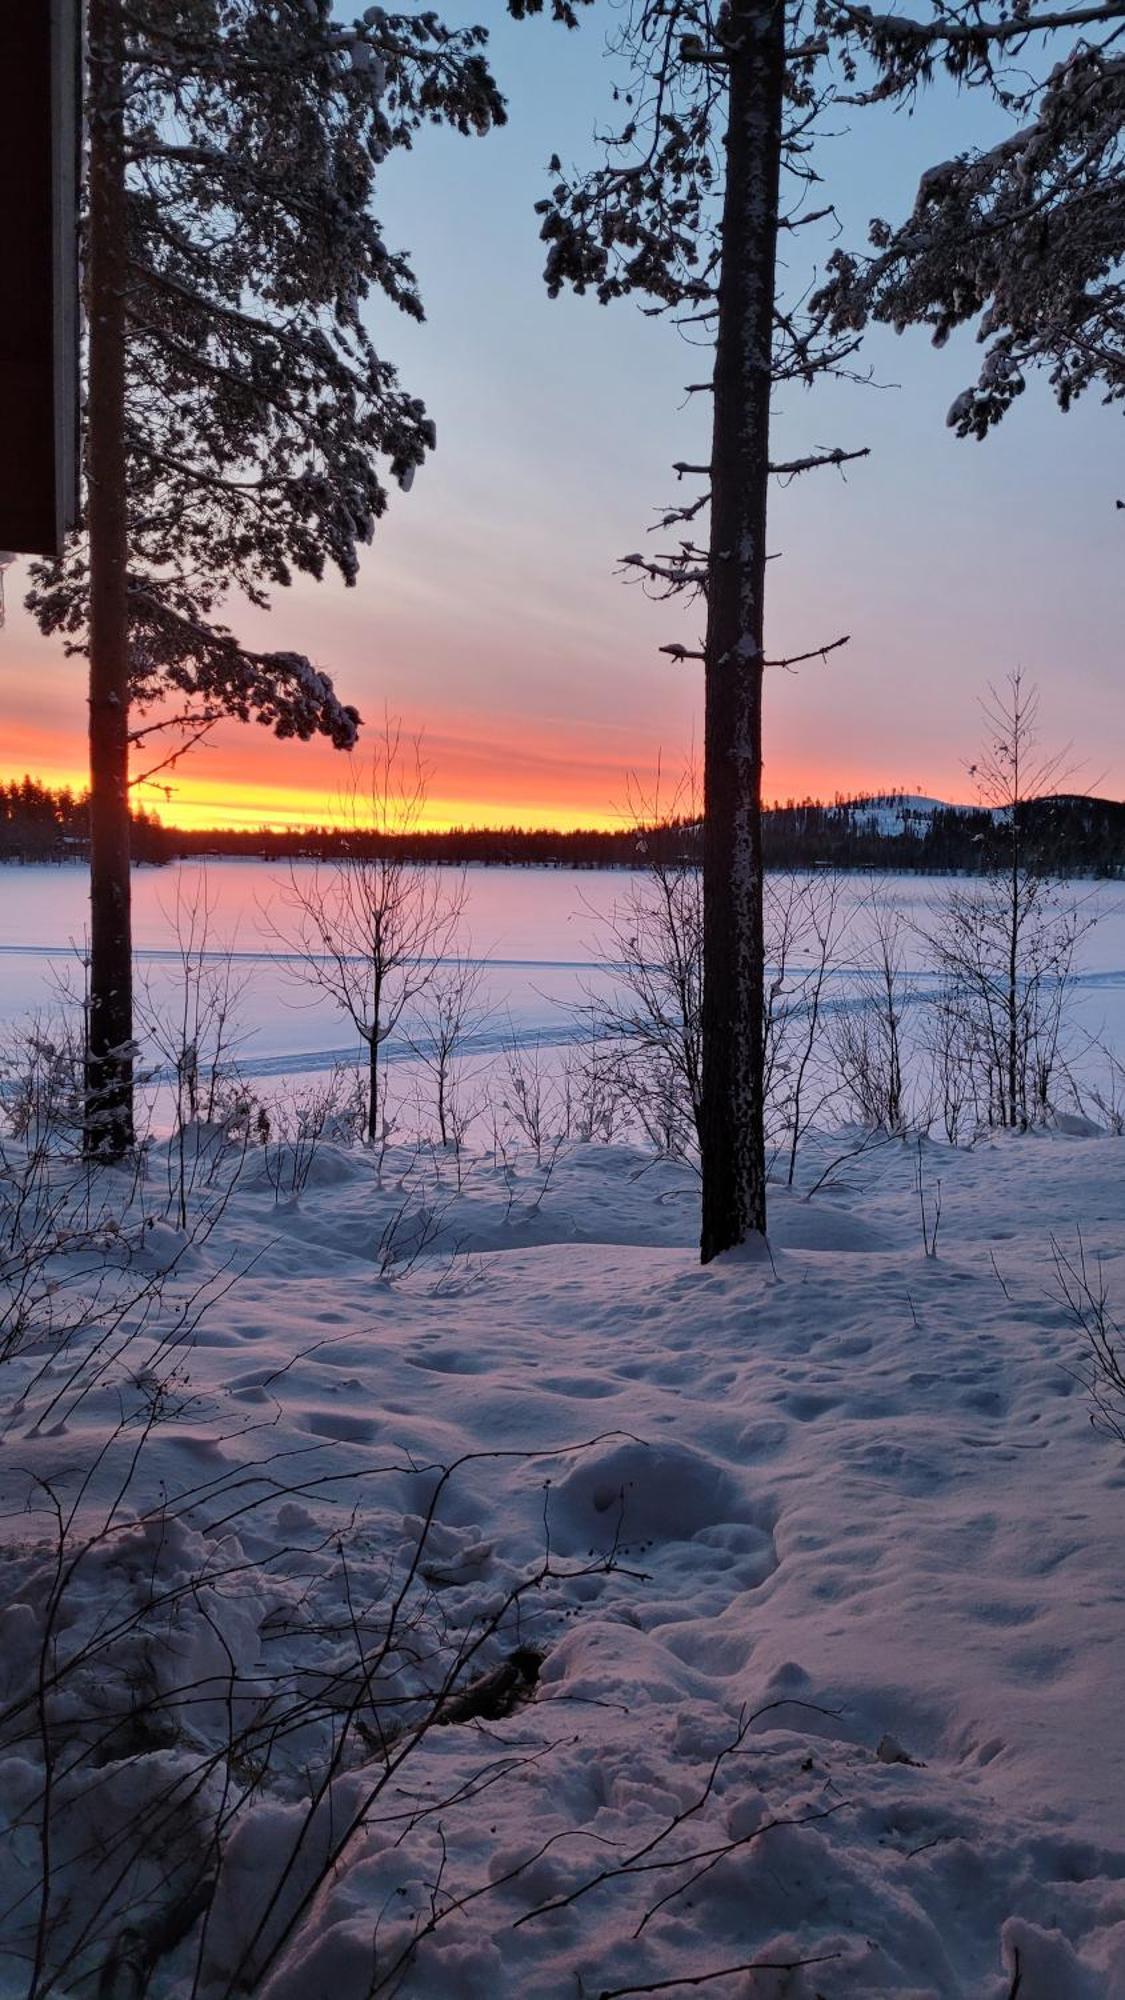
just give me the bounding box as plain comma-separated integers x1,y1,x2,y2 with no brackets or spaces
86,0,132,1160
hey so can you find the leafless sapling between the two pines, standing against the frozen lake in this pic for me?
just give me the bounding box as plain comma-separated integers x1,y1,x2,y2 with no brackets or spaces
266,716,468,1146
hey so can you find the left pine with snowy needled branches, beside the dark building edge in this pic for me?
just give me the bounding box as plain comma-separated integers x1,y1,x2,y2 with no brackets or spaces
28,0,504,1156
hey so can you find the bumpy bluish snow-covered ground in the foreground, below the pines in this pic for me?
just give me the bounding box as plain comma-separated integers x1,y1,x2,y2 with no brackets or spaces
0,1132,1125,2000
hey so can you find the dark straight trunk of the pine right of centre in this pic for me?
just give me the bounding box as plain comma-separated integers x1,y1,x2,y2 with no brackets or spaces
701,0,785,1264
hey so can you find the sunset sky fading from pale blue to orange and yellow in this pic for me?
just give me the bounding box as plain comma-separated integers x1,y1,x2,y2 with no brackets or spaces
0,0,1125,826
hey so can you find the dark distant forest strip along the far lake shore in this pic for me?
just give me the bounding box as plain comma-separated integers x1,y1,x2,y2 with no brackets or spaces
0,778,1125,876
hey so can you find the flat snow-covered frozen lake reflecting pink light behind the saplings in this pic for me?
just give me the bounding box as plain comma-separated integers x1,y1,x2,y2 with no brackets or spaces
0,860,1125,1112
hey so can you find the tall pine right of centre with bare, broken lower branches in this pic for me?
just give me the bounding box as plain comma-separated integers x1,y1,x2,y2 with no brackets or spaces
538,0,1125,1260
